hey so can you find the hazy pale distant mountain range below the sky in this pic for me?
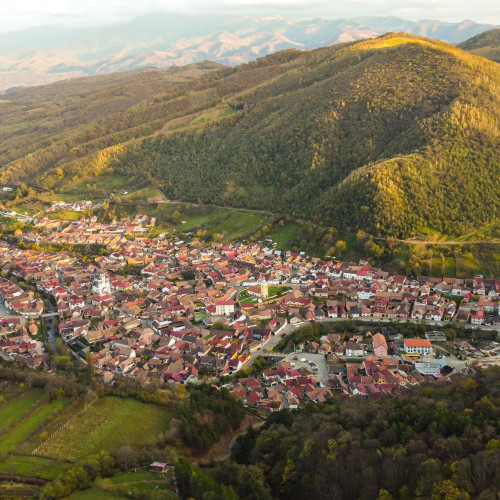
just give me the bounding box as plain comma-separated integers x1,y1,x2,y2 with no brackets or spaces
0,14,494,91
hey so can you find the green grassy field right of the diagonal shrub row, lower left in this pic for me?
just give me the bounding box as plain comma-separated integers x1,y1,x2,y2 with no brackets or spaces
39,397,171,460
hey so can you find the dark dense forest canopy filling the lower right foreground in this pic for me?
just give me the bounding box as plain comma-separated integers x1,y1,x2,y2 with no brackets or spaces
176,367,500,500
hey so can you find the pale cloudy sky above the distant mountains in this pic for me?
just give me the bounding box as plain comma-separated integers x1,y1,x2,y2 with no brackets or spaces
0,0,500,32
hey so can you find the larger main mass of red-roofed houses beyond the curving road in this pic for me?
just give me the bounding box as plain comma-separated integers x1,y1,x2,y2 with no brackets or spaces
0,216,500,390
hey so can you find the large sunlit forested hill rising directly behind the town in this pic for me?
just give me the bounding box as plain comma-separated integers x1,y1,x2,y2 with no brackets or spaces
0,34,500,236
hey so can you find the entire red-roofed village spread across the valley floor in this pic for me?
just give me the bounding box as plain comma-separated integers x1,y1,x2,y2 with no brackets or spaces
0,215,500,411
